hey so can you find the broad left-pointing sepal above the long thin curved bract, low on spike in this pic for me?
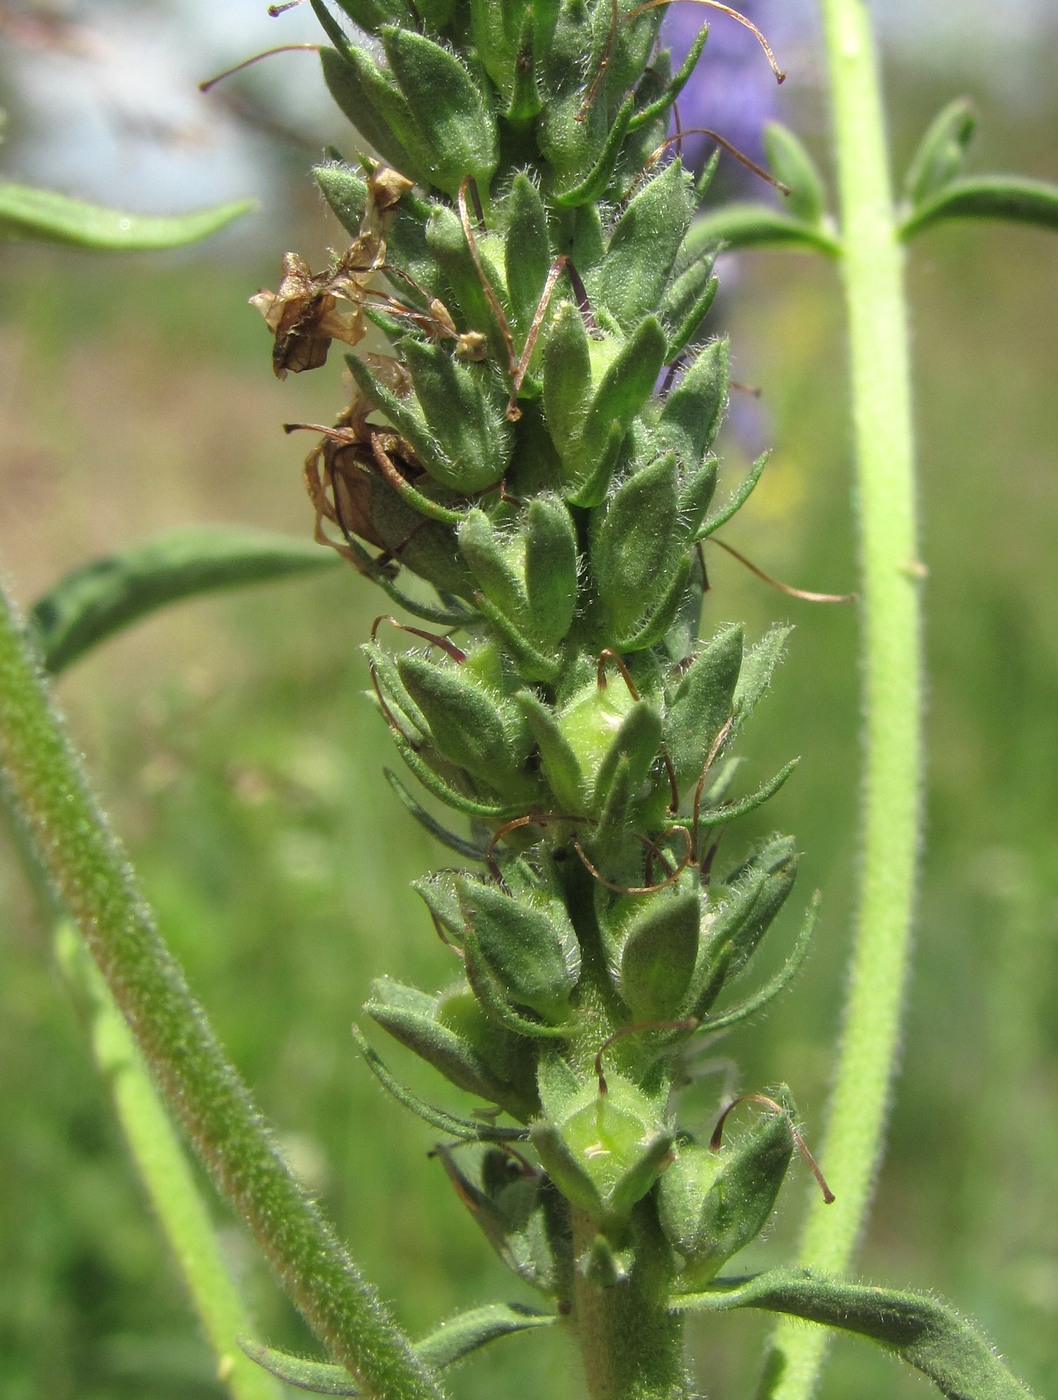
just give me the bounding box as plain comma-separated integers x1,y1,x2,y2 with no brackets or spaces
364,977,526,1117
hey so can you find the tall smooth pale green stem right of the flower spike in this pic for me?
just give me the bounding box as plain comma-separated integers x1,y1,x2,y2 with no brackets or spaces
766,0,922,1400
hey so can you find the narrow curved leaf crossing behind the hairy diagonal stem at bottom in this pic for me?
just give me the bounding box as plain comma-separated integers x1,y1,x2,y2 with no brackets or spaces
239,1303,557,1396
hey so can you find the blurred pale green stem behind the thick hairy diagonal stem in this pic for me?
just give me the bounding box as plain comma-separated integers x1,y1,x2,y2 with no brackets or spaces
56,921,280,1400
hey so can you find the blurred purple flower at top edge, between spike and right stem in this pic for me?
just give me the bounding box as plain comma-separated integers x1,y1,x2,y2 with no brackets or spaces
662,0,798,188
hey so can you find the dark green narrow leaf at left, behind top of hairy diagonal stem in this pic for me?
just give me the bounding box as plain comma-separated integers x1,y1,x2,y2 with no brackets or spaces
29,525,339,672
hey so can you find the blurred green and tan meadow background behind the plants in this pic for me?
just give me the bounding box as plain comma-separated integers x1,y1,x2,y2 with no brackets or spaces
0,7,1058,1400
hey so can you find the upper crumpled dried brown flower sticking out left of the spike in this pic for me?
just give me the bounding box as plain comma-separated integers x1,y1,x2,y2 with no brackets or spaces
251,234,386,379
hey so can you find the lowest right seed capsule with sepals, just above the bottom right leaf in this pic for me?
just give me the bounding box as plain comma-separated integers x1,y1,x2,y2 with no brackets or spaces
658,1091,795,1288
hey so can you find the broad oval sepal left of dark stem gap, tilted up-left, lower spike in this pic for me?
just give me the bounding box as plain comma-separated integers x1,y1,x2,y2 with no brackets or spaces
459,878,581,1025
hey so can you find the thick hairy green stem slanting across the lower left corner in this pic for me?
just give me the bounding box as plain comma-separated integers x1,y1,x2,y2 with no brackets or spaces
0,594,439,1400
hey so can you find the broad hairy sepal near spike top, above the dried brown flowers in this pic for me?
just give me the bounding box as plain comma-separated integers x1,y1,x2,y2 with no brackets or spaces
379,25,500,199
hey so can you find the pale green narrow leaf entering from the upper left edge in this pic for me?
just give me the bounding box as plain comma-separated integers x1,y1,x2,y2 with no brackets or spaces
0,181,256,252
